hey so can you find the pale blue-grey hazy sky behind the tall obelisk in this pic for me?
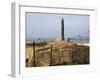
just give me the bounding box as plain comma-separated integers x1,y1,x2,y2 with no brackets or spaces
25,12,89,40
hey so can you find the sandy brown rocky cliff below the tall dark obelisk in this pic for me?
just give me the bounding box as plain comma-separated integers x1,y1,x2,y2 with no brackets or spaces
26,41,90,67
